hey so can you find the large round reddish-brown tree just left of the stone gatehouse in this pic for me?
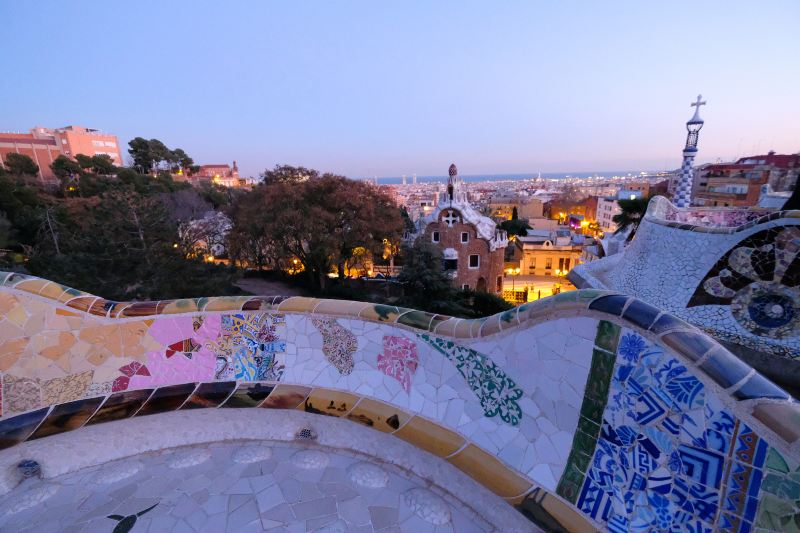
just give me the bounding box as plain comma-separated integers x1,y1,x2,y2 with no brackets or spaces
229,166,403,289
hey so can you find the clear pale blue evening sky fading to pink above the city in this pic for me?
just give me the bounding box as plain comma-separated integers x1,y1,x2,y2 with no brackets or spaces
0,0,800,177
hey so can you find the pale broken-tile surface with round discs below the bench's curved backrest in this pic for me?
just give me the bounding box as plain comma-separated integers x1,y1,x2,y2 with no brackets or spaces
0,441,494,533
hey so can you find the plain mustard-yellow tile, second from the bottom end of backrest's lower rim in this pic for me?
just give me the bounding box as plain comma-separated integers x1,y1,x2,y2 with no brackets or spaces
447,444,532,498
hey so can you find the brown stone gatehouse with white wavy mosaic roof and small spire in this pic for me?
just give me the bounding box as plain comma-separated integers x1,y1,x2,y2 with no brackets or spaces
415,165,508,294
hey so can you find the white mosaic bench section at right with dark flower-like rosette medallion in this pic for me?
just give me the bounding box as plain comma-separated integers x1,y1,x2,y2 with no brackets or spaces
569,196,800,362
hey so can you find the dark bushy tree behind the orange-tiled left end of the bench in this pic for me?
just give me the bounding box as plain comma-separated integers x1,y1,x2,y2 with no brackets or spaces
27,188,237,300
